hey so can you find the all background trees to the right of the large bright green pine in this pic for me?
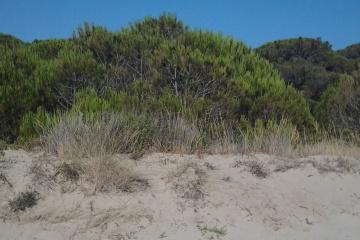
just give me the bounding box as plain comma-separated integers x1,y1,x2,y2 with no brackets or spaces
256,38,360,130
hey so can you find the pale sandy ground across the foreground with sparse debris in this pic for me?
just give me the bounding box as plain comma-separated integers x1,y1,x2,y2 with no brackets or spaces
0,150,360,240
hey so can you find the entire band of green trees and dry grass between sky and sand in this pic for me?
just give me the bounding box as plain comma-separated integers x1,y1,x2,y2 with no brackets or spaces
0,14,360,156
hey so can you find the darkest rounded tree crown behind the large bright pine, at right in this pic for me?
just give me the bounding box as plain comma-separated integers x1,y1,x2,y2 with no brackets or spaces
256,38,354,101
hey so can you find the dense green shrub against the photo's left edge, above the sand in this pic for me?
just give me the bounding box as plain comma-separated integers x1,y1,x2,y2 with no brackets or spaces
0,46,47,141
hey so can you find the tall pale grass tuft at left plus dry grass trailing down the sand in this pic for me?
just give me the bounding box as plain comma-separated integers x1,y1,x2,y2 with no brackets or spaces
36,114,153,193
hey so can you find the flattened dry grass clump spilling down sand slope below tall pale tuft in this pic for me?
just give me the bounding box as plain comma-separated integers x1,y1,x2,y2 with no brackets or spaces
31,154,144,194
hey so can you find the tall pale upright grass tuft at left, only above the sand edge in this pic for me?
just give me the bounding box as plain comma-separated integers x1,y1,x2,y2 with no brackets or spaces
42,114,148,158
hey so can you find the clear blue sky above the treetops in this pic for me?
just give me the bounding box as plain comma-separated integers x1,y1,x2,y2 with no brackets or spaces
0,0,360,49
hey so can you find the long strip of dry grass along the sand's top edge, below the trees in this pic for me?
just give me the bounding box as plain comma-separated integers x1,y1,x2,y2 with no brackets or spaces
41,113,360,159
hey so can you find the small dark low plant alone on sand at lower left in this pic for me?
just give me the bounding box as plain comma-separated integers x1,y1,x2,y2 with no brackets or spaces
9,190,39,212
